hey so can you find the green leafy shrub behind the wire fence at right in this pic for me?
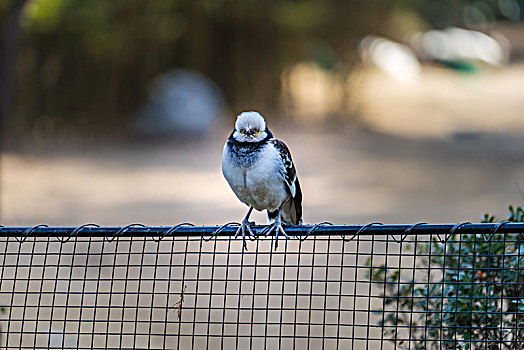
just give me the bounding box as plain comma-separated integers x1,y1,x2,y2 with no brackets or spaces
368,207,524,349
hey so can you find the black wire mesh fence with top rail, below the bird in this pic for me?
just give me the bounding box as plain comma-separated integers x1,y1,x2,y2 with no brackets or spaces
0,223,524,349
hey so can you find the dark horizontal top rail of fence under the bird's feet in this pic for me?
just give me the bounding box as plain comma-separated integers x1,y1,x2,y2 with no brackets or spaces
0,222,524,241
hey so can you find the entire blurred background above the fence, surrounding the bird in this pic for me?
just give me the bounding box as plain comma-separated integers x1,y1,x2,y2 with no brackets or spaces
0,0,524,226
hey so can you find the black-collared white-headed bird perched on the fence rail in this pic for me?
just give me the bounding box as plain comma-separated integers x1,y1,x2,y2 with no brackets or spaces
222,111,303,250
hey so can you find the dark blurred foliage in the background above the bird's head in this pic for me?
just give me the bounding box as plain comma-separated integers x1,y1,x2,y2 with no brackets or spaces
10,0,392,139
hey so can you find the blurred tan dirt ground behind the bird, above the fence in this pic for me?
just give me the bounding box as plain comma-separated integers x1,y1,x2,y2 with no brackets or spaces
0,125,524,226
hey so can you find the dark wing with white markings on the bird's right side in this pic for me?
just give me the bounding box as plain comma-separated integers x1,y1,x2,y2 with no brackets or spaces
269,139,302,225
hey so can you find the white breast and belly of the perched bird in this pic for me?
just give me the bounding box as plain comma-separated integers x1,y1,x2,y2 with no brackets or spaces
222,143,289,211
